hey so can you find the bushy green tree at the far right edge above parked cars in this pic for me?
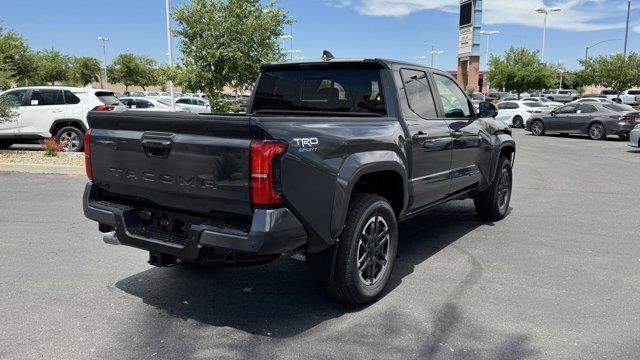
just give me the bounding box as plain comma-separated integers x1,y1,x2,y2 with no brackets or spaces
576,52,640,94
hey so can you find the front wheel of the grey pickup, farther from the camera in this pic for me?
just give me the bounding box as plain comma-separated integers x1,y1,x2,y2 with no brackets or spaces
473,156,513,221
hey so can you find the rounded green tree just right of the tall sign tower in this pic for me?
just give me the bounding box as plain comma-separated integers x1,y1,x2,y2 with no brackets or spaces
489,47,557,95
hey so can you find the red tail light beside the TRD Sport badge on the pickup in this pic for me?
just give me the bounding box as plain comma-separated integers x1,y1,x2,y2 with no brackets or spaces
250,141,287,205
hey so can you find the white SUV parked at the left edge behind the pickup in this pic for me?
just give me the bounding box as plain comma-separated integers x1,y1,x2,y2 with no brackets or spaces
0,86,124,151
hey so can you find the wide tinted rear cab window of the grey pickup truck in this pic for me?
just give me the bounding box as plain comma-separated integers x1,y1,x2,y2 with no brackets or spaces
253,68,387,115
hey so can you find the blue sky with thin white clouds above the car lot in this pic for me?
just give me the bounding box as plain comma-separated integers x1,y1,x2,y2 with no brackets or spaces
0,0,640,69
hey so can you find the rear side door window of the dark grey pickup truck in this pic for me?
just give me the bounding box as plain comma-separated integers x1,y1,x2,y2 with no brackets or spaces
400,69,438,119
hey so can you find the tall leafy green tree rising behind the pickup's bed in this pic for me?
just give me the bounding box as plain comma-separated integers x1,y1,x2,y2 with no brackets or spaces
173,0,292,111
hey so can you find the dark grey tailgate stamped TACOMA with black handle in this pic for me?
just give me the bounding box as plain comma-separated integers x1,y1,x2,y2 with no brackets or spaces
88,112,251,215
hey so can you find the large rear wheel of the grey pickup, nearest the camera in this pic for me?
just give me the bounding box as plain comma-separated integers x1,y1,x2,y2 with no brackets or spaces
327,194,398,305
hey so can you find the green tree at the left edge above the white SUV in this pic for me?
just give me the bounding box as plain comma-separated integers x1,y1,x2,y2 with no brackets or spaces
0,25,36,84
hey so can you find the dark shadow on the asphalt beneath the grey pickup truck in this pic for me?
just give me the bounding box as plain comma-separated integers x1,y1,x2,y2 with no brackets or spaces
116,201,500,338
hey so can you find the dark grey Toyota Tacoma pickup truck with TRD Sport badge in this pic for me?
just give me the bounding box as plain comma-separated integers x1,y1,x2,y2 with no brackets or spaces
83,59,516,304
